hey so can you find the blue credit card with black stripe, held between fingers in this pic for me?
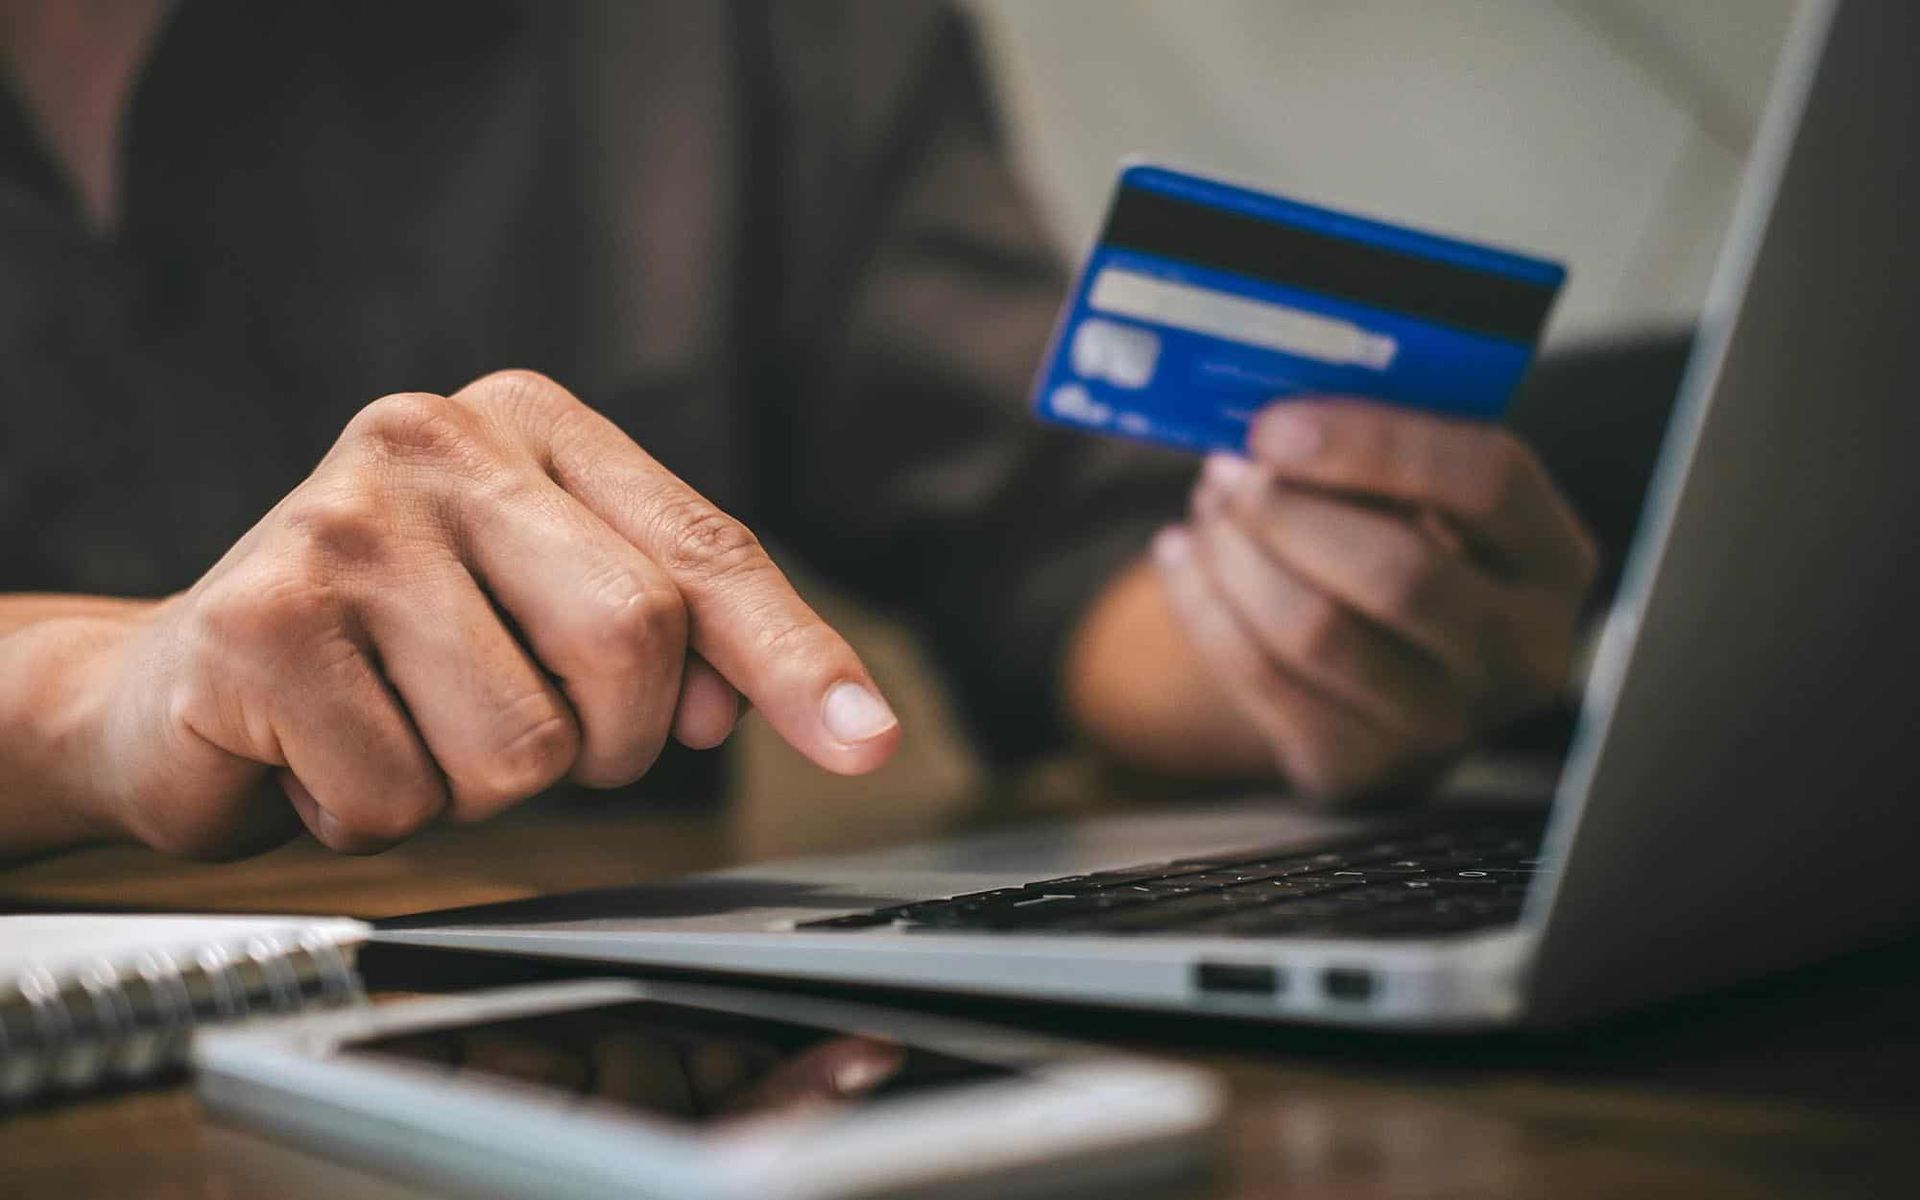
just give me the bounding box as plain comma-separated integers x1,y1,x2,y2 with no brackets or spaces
1033,163,1567,451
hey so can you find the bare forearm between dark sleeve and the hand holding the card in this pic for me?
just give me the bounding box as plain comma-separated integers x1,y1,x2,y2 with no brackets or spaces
1064,561,1275,780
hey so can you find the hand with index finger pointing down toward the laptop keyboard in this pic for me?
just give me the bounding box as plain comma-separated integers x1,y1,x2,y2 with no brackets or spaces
78,371,899,856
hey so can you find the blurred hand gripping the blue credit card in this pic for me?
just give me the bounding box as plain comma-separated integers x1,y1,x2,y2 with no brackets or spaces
1154,399,1597,795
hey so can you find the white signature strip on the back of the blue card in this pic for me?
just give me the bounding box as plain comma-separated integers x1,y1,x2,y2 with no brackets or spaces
1087,267,1400,371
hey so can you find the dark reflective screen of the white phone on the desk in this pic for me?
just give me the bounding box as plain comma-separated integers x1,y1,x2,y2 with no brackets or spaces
346,1000,1018,1125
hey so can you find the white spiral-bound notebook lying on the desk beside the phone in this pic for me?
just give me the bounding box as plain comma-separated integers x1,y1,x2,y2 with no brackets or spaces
0,914,369,1106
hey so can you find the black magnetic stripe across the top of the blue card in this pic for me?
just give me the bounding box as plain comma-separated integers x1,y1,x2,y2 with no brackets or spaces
1100,188,1555,344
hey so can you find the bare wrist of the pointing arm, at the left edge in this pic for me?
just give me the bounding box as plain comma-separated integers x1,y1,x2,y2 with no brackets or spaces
0,595,148,858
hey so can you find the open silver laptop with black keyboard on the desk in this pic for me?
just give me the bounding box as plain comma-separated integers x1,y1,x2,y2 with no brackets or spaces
378,0,1920,1029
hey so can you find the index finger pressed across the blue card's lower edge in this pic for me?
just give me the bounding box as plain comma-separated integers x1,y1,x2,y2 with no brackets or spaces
1246,399,1597,586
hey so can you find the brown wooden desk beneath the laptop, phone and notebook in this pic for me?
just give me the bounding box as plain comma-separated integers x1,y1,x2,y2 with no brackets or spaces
0,814,1920,1200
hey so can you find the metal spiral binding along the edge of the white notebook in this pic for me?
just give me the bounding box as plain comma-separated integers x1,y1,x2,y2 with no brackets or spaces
0,933,365,1104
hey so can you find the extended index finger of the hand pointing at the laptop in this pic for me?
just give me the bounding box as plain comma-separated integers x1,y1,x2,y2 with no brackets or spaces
455,371,900,774
